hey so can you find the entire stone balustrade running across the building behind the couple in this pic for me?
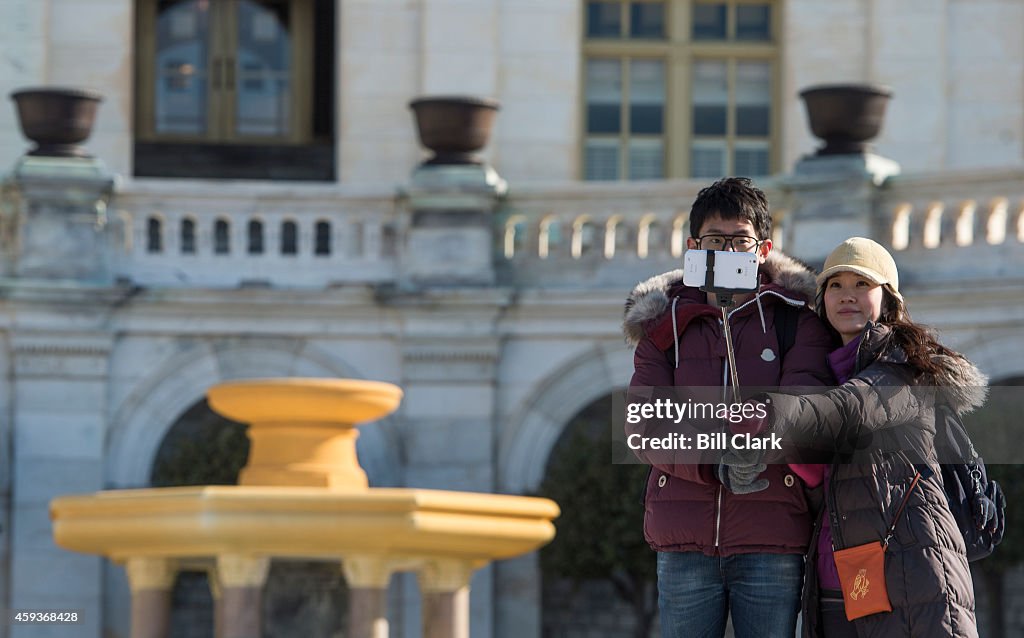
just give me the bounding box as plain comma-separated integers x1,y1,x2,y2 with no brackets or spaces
109,170,1024,288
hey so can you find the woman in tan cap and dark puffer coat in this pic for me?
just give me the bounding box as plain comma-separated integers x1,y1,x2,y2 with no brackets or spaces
762,238,995,638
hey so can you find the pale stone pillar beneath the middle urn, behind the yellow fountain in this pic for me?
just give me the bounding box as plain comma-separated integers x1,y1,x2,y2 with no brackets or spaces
389,160,510,638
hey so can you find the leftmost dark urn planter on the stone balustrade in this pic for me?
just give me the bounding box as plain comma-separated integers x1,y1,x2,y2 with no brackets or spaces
10,87,102,158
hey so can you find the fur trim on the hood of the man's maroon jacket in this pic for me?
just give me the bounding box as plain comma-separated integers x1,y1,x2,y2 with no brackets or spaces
623,250,816,347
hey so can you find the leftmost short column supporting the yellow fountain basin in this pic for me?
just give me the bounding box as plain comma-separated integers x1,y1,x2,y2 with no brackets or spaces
125,557,177,638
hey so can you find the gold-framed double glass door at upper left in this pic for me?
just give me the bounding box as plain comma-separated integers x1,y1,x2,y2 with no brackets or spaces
138,0,312,143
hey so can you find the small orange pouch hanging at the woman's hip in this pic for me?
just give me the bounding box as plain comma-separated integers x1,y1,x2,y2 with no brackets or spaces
834,541,893,621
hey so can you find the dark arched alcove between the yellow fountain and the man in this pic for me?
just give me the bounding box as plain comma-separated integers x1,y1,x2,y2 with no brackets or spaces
538,394,657,638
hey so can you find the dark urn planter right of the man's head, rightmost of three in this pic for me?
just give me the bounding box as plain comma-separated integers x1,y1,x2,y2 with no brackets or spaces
800,84,892,156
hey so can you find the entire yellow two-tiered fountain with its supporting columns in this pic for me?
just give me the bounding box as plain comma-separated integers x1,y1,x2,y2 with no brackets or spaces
50,379,559,638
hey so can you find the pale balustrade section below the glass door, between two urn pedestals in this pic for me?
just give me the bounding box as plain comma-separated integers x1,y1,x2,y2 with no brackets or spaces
108,180,399,288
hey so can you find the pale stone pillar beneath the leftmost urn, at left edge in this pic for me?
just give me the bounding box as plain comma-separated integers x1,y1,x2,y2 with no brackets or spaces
0,157,117,638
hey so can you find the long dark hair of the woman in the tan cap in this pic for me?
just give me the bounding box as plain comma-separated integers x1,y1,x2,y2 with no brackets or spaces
814,278,959,379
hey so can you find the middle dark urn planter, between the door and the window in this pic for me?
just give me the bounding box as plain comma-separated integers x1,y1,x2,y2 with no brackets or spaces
409,96,499,165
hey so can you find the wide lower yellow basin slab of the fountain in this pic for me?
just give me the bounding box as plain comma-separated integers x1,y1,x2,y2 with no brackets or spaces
50,485,559,561
